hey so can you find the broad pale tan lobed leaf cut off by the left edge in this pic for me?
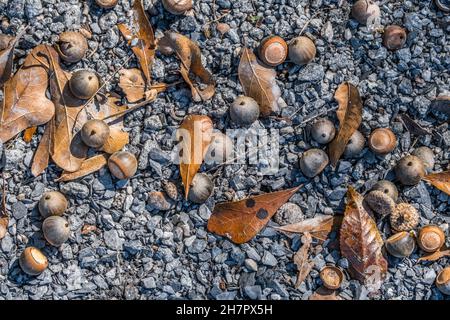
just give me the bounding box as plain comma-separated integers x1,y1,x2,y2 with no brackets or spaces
0,45,55,143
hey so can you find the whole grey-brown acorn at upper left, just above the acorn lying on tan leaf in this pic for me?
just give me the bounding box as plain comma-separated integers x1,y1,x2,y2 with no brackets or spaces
56,31,88,63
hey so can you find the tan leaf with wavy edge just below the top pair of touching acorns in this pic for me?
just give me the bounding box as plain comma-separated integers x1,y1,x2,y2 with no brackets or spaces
238,48,281,116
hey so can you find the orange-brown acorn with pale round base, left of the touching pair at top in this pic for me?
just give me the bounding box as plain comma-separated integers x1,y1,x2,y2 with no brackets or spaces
258,36,288,67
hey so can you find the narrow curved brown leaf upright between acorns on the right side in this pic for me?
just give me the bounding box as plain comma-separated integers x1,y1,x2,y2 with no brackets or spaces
328,82,362,167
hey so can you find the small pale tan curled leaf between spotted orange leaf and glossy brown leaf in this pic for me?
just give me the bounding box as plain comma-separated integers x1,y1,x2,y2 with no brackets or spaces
275,215,343,242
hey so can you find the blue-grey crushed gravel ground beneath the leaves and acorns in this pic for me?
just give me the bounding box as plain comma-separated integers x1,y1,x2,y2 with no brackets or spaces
0,0,450,300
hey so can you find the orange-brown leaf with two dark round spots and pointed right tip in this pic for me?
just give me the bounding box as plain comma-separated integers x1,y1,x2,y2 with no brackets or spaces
208,186,301,244
